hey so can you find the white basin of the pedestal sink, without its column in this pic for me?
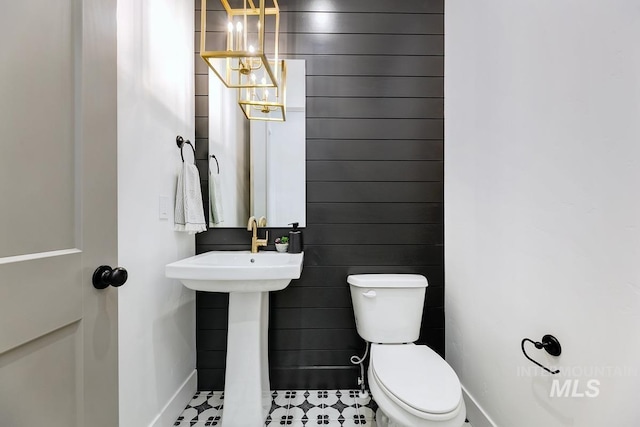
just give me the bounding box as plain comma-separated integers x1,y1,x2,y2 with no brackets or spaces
165,251,303,292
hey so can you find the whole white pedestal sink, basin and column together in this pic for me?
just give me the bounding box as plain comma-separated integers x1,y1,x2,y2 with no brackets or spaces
165,251,303,427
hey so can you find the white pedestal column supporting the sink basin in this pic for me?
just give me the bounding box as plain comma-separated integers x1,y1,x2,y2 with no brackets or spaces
222,292,271,427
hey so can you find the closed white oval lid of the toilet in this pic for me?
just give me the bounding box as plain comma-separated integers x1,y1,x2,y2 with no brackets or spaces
371,344,462,414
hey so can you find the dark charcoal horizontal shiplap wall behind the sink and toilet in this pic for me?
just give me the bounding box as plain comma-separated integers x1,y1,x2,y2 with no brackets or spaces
195,0,444,390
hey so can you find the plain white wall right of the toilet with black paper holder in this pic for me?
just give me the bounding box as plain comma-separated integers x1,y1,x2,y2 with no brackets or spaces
445,0,640,427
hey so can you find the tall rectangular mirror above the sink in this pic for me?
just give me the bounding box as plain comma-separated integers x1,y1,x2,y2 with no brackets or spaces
209,59,306,227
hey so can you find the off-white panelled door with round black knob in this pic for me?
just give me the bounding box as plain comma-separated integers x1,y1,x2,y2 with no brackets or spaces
0,0,118,427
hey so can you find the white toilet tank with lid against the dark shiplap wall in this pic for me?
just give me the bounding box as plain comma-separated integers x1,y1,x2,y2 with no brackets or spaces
347,274,428,344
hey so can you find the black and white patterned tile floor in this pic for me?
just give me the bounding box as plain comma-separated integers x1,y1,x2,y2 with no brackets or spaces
174,390,377,427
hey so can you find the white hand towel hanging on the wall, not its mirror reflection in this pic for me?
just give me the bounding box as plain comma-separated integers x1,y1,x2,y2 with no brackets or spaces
174,163,207,234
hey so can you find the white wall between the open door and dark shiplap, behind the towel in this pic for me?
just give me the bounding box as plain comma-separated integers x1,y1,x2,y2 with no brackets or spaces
118,0,195,427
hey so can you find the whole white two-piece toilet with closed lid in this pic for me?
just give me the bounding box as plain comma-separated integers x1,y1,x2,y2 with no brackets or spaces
347,274,466,427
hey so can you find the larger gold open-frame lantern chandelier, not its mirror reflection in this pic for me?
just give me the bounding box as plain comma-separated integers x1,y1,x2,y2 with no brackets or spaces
200,0,281,89
